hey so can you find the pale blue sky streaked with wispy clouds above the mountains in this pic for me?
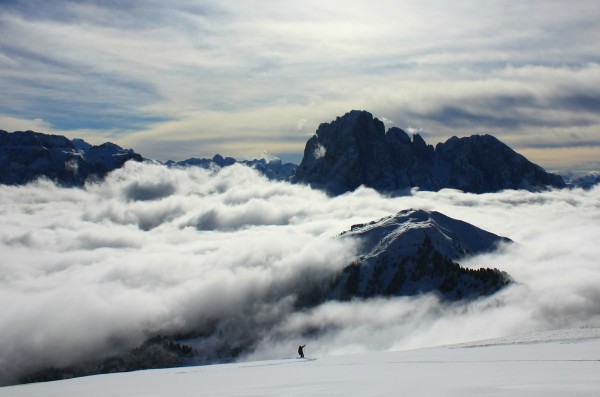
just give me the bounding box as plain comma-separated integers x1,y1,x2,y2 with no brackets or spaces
0,0,600,170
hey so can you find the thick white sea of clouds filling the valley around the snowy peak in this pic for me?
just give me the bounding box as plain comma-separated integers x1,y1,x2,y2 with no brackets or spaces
0,162,600,384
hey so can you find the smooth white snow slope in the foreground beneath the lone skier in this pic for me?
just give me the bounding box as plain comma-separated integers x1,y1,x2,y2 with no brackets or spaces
0,329,600,397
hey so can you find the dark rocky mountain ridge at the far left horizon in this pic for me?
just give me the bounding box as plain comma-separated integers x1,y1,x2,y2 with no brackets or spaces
0,130,143,186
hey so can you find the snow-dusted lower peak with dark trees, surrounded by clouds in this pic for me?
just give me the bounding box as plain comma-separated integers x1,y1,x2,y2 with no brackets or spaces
330,209,511,300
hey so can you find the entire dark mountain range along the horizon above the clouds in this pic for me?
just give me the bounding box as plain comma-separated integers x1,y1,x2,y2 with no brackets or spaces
0,110,600,195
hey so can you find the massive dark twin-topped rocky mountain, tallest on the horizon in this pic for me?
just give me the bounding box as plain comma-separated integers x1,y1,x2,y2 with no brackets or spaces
293,110,565,195
